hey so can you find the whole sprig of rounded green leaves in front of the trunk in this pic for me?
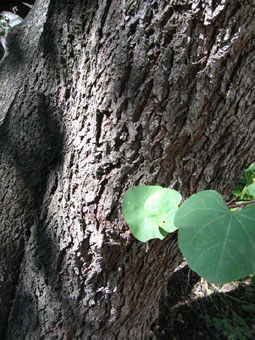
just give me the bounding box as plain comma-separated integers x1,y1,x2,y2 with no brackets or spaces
123,165,255,284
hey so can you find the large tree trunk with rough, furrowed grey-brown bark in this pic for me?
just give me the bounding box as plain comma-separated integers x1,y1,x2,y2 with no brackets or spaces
0,0,255,340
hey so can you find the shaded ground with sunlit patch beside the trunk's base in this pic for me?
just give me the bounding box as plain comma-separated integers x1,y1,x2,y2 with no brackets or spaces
152,261,255,340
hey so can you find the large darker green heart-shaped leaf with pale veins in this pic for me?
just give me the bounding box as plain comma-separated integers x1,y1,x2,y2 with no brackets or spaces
174,190,255,284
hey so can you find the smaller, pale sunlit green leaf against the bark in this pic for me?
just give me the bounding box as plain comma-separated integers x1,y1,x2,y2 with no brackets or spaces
122,185,182,242
